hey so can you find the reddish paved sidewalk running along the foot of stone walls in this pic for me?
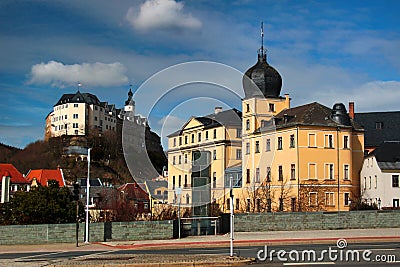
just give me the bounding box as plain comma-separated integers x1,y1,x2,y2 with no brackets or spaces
0,228,400,253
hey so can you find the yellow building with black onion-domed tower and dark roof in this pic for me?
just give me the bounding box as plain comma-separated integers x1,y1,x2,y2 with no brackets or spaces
239,39,364,212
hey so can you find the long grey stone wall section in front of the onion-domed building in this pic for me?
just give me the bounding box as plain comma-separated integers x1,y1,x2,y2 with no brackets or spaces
235,210,400,232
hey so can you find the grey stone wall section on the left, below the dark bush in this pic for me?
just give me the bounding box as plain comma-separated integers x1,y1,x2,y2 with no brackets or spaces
0,221,173,245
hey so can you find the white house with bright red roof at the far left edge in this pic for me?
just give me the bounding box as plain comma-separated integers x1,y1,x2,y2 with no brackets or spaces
0,163,30,203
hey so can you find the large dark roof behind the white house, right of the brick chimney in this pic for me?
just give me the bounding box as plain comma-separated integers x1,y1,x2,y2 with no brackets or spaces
354,111,400,147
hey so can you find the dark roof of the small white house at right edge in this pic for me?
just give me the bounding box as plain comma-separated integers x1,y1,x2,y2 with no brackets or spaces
368,142,400,170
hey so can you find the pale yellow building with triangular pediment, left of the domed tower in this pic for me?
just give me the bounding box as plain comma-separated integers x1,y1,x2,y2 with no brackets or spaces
168,107,242,211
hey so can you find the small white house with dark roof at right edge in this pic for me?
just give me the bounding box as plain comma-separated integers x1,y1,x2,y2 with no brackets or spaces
361,141,400,208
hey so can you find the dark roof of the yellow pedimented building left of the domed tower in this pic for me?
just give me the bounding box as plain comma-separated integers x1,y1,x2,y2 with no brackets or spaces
167,108,242,137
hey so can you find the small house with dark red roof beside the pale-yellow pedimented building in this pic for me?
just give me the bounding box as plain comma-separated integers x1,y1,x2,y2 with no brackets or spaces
117,182,150,213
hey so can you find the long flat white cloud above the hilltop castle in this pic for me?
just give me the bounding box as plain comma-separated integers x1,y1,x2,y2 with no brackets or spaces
28,61,128,87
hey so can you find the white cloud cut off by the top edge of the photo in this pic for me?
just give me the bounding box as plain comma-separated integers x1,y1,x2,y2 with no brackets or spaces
126,0,202,31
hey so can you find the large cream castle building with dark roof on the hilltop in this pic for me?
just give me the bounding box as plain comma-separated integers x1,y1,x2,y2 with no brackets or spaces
45,90,118,140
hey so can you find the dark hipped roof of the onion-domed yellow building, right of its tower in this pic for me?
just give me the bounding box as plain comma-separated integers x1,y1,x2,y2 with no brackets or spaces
258,102,362,131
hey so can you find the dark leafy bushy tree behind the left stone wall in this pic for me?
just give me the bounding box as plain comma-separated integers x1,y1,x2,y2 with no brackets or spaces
0,181,85,224
